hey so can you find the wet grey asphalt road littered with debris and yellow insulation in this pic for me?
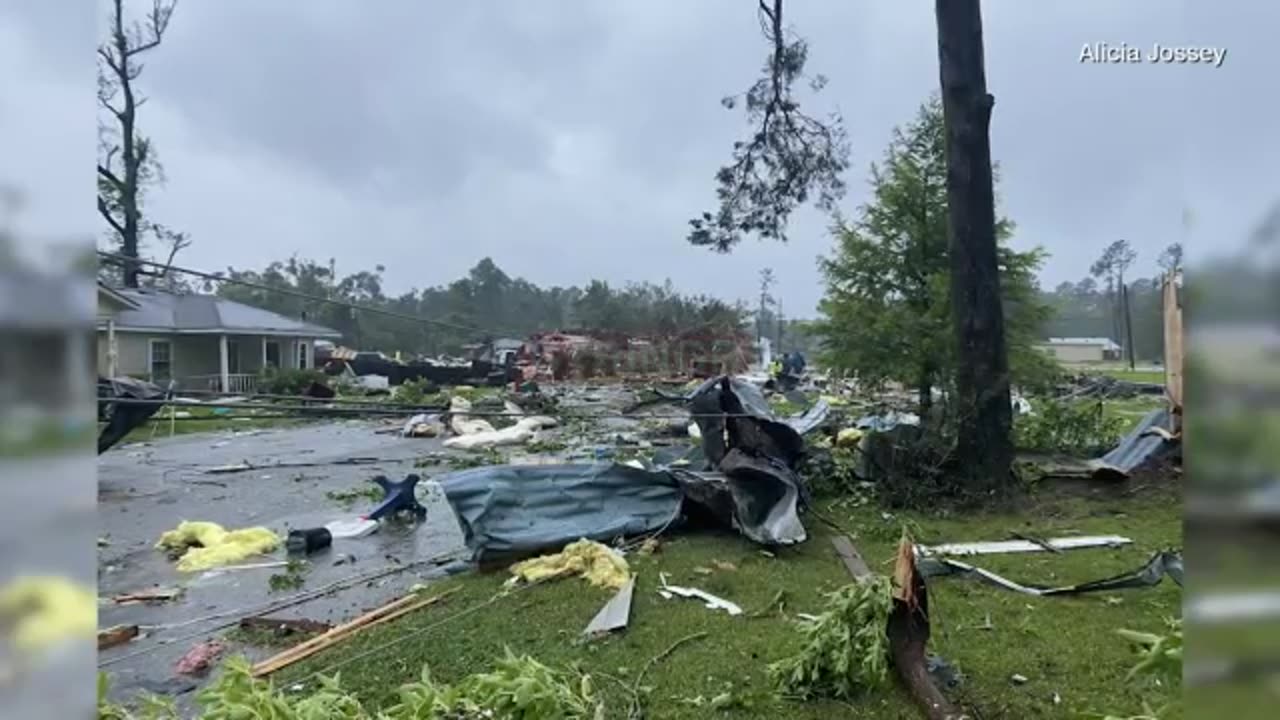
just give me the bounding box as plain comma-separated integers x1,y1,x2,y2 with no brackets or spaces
97,420,476,707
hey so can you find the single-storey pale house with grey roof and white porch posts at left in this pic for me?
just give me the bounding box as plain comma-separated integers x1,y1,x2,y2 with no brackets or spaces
97,284,342,392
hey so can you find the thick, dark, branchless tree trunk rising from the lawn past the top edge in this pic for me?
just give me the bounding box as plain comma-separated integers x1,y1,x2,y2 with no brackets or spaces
934,0,1014,489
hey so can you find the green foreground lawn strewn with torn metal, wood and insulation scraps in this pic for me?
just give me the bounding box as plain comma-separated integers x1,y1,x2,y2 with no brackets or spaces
264,491,1181,719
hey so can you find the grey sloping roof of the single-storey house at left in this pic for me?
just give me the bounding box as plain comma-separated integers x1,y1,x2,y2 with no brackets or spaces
101,290,342,337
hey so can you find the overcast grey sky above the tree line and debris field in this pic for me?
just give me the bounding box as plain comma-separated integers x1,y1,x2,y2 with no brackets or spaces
0,0,1280,315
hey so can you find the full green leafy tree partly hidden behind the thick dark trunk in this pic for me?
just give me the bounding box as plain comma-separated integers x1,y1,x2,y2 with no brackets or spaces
815,97,1056,407
